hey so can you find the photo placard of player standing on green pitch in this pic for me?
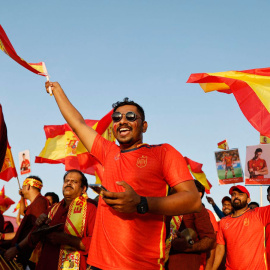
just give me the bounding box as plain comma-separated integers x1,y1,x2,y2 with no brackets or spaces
215,148,244,185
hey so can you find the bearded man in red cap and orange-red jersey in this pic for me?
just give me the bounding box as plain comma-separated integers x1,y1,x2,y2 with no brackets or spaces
213,185,270,270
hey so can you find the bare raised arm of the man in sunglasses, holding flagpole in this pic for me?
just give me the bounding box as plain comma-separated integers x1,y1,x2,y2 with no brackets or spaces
45,82,97,152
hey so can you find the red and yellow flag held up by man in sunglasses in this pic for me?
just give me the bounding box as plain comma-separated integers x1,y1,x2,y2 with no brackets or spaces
0,25,48,76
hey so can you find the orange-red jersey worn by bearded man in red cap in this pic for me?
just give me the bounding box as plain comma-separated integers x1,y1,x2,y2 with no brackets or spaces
217,206,270,270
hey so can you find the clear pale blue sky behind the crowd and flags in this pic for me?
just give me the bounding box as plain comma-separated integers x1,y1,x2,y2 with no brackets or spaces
0,0,270,214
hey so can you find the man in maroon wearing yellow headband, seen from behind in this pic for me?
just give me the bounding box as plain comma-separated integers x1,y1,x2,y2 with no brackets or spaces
1,176,49,269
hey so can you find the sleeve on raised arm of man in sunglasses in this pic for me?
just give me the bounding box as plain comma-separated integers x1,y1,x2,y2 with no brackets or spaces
91,134,115,164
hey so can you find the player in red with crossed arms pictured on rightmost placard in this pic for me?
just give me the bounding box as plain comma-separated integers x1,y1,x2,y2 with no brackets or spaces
248,148,268,179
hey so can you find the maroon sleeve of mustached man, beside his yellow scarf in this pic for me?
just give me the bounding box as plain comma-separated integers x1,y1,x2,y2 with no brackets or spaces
80,203,97,256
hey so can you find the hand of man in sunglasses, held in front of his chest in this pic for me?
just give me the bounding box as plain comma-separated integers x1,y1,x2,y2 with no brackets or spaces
101,181,141,213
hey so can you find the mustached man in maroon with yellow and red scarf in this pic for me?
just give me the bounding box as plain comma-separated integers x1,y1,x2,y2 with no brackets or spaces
29,170,96,270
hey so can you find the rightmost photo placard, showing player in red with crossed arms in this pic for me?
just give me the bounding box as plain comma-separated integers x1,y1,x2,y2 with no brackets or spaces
245,144,270,185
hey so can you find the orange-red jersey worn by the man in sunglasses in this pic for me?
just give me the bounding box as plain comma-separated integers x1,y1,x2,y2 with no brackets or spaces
87,135,192,270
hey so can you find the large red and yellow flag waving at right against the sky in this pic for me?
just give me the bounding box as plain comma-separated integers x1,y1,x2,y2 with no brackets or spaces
187,68,270,137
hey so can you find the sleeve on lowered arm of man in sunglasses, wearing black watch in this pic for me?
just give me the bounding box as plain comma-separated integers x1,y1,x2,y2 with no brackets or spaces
162,144,193,187
